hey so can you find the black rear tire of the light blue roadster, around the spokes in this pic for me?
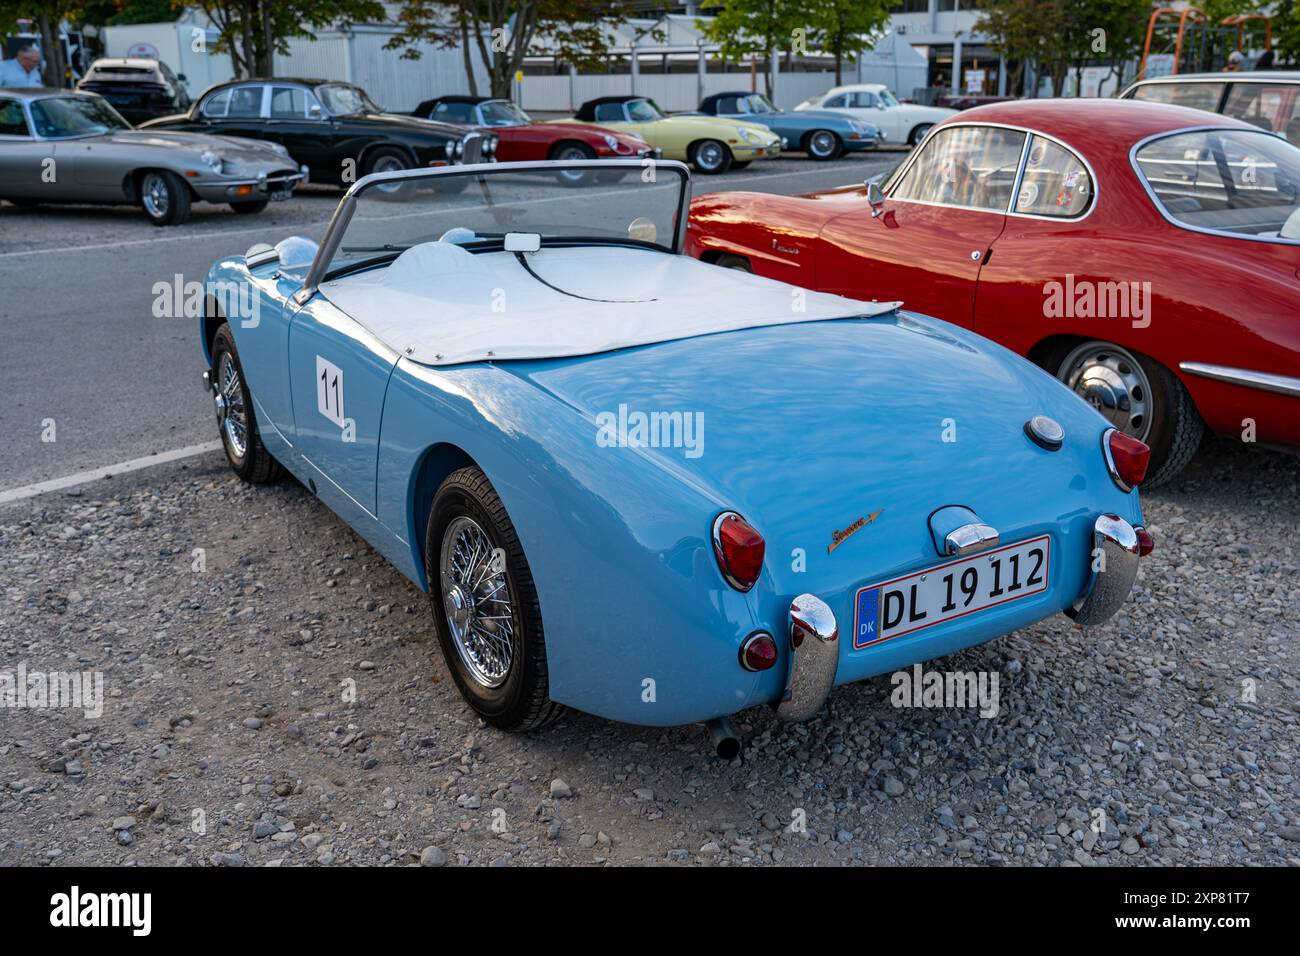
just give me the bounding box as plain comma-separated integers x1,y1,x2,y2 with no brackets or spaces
424,467,564,732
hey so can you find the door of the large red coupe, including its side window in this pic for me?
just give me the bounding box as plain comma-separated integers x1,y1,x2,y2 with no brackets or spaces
816,125,1026,328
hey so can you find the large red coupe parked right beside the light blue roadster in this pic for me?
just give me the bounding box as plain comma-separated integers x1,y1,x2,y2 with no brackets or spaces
686,99,1300,486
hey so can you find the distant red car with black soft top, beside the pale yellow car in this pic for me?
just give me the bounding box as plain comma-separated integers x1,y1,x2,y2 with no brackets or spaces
413,96,655,163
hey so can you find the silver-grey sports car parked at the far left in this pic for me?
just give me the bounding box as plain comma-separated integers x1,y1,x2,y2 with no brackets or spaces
0,88,307,226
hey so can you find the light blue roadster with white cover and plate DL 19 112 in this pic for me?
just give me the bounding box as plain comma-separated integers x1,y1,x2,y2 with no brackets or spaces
200,160,1149,756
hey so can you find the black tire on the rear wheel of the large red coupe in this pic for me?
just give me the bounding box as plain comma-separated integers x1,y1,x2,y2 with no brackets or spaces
1044,341,1205,490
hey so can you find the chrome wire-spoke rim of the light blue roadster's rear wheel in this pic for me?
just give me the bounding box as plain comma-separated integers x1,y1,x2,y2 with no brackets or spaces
439,515,515,688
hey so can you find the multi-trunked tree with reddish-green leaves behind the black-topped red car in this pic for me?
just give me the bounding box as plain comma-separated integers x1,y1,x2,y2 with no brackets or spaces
386,0,644,96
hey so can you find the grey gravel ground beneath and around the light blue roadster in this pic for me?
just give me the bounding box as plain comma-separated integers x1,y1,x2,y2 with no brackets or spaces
0,441,1300,866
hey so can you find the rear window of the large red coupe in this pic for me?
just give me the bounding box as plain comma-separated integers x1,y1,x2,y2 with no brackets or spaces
1135,130,1300,241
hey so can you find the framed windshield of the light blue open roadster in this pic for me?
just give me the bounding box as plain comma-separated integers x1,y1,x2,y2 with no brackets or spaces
325,160,688,278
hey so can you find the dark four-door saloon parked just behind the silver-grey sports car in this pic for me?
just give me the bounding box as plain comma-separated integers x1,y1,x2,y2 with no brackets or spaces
142,77,497,186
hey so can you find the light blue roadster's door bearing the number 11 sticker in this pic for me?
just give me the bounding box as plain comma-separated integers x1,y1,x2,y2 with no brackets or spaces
289,293,398,520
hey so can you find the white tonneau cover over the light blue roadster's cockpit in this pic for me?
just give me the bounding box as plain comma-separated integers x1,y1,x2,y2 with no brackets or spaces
321,242,901,365
